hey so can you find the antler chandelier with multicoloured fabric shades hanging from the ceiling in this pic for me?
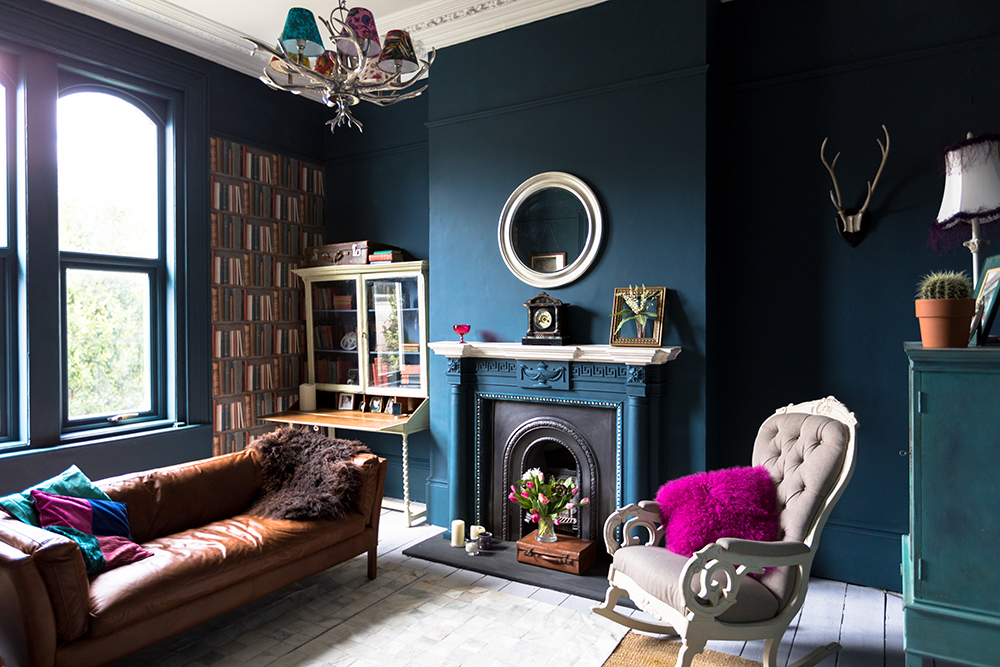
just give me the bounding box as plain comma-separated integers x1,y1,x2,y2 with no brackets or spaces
243,0,434,132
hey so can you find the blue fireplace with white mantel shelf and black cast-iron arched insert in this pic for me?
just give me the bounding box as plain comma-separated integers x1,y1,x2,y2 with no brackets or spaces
430,342,680,540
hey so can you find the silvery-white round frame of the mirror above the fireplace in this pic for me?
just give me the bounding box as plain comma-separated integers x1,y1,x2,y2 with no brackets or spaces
497,171,604,288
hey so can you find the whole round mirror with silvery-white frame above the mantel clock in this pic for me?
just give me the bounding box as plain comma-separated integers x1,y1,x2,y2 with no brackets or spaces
497,171,602,287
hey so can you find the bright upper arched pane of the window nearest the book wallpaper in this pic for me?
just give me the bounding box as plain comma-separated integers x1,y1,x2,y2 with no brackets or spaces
58,93,159,258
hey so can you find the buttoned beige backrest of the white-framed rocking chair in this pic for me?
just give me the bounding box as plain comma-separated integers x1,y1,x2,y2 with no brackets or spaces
753,396,857,608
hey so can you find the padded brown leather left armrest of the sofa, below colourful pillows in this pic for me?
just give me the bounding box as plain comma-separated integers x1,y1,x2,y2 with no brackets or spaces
0,518,90,641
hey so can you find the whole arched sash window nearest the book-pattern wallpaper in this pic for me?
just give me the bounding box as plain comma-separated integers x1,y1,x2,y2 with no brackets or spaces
58,86,169,430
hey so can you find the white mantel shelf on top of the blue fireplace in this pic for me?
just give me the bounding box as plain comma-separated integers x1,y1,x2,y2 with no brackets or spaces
428,341,681,366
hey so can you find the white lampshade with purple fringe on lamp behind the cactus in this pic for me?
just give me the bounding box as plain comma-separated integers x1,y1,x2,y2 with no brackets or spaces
927,134,1000,254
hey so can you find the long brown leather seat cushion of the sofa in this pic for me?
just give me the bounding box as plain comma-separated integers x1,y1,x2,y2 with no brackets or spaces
89,513,367,637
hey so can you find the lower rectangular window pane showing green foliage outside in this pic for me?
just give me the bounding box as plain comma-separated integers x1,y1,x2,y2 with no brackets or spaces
66,269,151,420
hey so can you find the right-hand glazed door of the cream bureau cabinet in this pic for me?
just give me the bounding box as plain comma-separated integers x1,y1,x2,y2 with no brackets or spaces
364,275,427,396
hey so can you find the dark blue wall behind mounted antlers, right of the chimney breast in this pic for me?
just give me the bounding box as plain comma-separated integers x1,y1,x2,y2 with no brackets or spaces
709,0,1000,590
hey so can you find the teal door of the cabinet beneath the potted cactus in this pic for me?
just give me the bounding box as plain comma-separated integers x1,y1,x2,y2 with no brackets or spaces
910,372,1000,612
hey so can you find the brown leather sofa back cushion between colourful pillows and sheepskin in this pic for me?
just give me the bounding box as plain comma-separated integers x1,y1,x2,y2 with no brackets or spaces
98,450,261,544
